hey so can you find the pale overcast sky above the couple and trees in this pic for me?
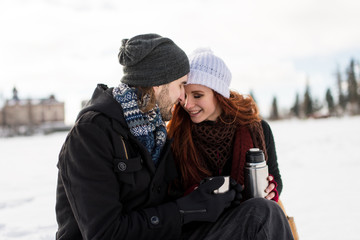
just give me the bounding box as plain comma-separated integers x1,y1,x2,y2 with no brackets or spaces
0,0,360,123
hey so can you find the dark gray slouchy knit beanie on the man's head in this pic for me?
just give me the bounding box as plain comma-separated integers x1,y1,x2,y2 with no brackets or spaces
118,34,190,87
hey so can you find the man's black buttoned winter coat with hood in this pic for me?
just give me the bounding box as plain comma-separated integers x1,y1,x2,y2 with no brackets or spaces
56,85,181,240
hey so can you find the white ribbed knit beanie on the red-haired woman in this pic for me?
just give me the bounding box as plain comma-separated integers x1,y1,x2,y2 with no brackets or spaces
187,48,231,98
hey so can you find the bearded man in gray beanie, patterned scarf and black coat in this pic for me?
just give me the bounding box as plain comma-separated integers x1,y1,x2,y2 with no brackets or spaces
56,34,235,240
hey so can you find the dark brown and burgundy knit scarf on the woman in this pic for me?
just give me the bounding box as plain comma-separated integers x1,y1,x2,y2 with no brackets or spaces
192,117,267,183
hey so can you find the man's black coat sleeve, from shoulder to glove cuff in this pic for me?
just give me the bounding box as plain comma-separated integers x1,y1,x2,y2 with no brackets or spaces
58,119,181,240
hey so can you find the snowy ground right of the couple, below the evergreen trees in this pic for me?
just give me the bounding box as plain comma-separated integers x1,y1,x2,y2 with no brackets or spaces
271,117,360,240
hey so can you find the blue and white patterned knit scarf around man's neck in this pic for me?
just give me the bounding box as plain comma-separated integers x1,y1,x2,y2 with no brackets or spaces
113,83,167,166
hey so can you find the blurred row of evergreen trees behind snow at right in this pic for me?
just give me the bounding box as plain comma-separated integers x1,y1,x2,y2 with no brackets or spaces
262,59,360,120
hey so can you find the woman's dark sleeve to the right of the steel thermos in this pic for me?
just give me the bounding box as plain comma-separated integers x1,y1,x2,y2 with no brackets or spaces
261,120,283,195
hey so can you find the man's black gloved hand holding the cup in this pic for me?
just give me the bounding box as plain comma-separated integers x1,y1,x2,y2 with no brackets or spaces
176,176,235,224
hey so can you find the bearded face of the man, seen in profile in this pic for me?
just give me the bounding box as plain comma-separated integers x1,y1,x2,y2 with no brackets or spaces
155,75,187,121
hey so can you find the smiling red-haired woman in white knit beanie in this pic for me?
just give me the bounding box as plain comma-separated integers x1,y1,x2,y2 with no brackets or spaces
168,49,282,201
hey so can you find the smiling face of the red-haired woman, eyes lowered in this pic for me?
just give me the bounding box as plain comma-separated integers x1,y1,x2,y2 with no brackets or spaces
180,84,222,123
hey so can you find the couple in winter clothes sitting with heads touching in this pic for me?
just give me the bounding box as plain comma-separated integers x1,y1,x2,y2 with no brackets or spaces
56,34,292,240
